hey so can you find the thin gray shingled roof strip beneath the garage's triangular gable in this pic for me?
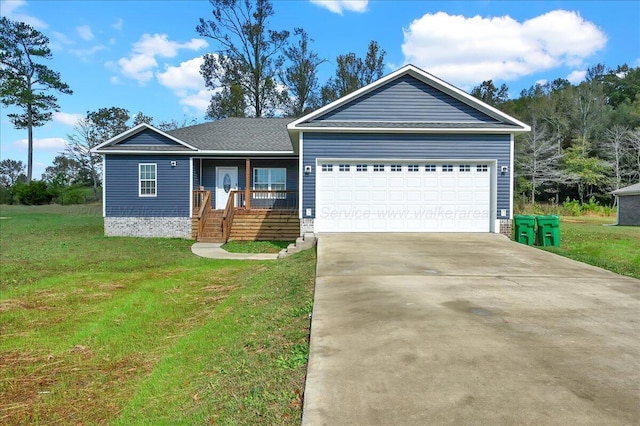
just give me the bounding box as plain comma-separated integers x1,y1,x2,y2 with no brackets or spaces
298,120,518,129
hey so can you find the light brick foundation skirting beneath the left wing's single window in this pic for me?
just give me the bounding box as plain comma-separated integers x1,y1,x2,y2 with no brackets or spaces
104,217,191,240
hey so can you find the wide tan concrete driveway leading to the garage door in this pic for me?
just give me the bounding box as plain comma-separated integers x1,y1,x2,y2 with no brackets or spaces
303,234,640,425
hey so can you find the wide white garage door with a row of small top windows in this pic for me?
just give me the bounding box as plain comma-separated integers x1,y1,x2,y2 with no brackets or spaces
314,160,491,232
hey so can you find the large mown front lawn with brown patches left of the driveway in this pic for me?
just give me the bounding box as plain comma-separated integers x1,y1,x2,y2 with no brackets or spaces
0,206,315,425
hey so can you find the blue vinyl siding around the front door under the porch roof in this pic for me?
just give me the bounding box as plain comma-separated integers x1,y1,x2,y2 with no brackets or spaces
195,158,298,206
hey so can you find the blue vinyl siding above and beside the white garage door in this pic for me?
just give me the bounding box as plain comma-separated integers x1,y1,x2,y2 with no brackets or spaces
300,133,511,218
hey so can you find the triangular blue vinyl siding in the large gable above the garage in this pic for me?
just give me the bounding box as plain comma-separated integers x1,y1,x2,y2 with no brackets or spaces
314,75,498,123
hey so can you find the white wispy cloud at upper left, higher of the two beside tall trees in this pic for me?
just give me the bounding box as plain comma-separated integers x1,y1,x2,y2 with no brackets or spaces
118,34,208,85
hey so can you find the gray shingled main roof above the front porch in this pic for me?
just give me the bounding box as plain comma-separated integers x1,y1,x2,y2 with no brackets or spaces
167,118,294,152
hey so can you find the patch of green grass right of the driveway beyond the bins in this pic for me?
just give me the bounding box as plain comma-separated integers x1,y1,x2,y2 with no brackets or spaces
544,216,640,279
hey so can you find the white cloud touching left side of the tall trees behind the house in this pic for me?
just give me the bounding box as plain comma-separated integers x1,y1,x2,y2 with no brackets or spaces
156,56,214,112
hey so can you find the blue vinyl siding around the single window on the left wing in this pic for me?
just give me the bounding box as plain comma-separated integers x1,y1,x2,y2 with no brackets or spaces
105,154,191,217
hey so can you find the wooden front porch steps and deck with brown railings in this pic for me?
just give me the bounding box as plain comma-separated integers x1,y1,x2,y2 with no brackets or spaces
191,189,300,243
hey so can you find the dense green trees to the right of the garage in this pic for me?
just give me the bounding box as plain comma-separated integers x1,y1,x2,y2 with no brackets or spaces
471,64,640,208
